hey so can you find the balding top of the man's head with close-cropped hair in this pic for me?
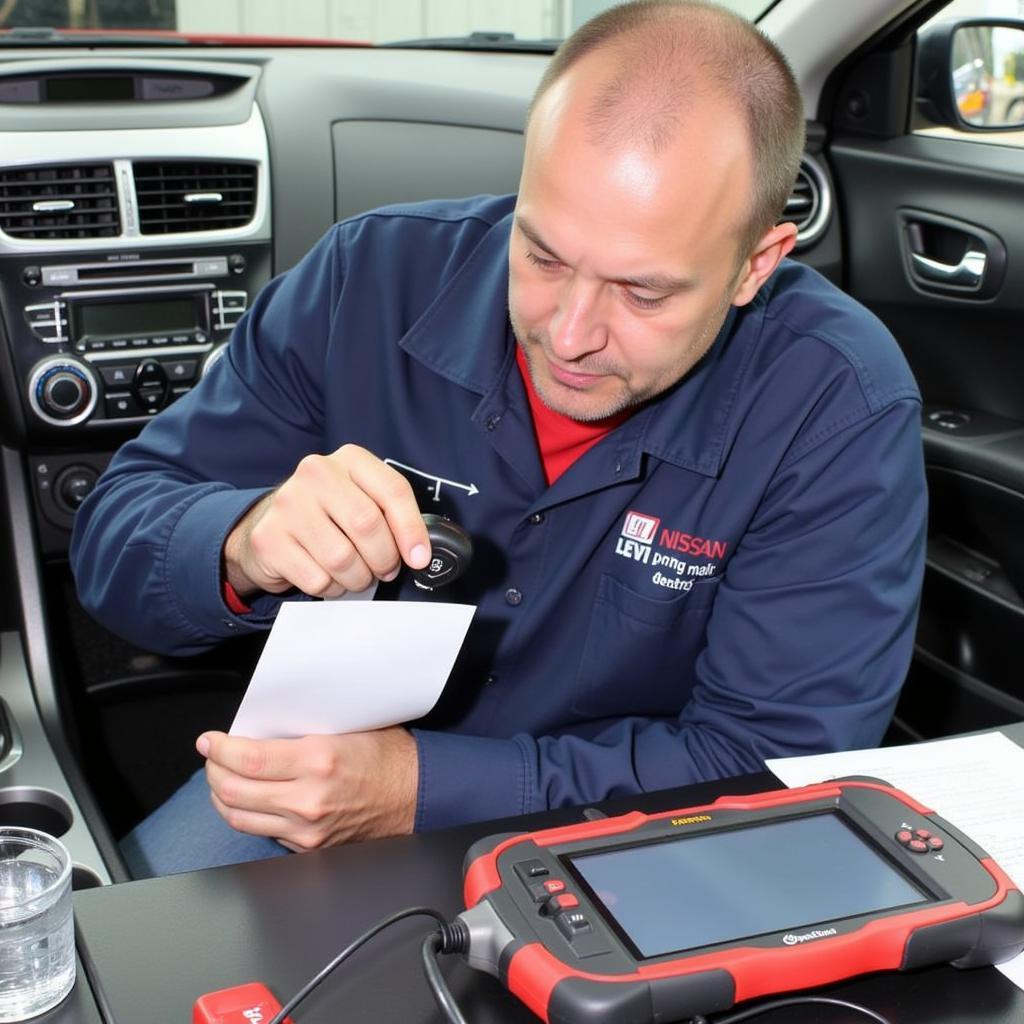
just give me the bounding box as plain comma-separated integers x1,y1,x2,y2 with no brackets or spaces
527,0,804,248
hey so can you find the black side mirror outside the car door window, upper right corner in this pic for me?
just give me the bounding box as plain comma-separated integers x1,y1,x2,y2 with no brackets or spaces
916,18,1024,131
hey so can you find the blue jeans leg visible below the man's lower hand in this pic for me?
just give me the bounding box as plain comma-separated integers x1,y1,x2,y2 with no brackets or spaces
121,768,289,879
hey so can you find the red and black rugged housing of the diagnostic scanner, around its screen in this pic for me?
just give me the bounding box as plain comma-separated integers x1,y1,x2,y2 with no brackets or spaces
461,779,1024,1024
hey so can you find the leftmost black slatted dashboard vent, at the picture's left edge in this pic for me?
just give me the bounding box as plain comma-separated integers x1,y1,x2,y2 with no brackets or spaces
0,164,121,239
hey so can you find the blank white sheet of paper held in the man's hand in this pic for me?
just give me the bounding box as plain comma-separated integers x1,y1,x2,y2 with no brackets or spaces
230,600,476,739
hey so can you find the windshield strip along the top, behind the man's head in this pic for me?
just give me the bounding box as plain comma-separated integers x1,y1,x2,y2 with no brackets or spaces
0,0,772,43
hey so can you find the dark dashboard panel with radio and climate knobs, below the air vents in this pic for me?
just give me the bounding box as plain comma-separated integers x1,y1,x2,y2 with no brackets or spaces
0,242,270,555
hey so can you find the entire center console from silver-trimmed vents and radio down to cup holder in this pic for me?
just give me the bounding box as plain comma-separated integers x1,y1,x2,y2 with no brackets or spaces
0,54,272,885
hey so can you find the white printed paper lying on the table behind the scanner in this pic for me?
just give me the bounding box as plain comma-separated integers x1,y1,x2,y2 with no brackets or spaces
765,732,1024,988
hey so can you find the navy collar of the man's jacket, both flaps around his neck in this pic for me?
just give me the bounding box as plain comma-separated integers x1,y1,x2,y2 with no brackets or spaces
399,214,764,477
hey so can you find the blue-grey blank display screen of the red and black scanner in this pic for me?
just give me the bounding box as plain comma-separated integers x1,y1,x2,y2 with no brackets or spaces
565,813,930,958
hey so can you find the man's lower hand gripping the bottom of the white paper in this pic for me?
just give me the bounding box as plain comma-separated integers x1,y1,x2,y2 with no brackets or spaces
196,726,420,853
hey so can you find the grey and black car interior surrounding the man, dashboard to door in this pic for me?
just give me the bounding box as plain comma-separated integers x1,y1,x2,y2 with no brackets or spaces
0,0,1024,887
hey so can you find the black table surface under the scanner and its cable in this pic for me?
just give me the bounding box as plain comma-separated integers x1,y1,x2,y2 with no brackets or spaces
70,724,1024,1024
